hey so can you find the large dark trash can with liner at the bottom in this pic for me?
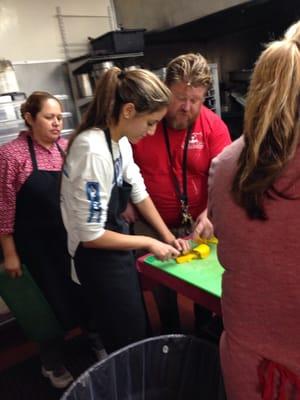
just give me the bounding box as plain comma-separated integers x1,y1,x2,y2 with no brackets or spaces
61,335,226,400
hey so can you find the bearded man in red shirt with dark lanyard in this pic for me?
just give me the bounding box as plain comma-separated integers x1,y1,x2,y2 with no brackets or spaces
133,54,231,333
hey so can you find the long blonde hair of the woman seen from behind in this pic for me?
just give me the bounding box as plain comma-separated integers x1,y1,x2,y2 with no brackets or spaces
232,21,300,220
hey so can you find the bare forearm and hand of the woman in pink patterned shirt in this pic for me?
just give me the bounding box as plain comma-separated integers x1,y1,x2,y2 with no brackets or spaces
0,234,22,278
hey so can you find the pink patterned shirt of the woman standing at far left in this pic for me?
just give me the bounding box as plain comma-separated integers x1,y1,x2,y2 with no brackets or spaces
0,131,67,235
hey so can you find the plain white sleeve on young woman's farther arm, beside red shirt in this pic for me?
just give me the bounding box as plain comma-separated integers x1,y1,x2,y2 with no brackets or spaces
121,138,149,204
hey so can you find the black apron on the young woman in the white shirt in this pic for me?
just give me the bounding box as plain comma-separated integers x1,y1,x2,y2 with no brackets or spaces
74,131,147,352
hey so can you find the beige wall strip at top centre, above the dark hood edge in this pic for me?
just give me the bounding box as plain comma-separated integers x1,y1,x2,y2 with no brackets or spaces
114,0,249,30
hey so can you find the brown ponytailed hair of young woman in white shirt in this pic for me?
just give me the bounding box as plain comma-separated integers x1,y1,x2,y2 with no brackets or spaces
69,67,171,148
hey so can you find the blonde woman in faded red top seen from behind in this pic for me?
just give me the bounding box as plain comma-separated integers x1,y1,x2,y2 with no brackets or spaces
209,22,300,400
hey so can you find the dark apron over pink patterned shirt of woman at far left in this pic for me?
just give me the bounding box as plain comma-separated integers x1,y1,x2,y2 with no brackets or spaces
14,137,77,329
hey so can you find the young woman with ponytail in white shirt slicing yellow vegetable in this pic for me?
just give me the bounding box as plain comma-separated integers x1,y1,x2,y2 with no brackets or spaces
61,67,187,352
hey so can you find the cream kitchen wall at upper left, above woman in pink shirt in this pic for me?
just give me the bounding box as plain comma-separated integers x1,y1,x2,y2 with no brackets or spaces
0,0,116,123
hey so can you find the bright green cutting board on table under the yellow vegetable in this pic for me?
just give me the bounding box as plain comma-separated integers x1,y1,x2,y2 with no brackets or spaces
145,244,224,297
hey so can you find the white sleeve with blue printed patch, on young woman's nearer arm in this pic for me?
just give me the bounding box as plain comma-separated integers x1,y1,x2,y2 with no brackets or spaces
72,153,113,242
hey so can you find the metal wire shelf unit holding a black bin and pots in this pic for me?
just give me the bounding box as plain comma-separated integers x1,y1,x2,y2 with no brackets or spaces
56,7,144,122
